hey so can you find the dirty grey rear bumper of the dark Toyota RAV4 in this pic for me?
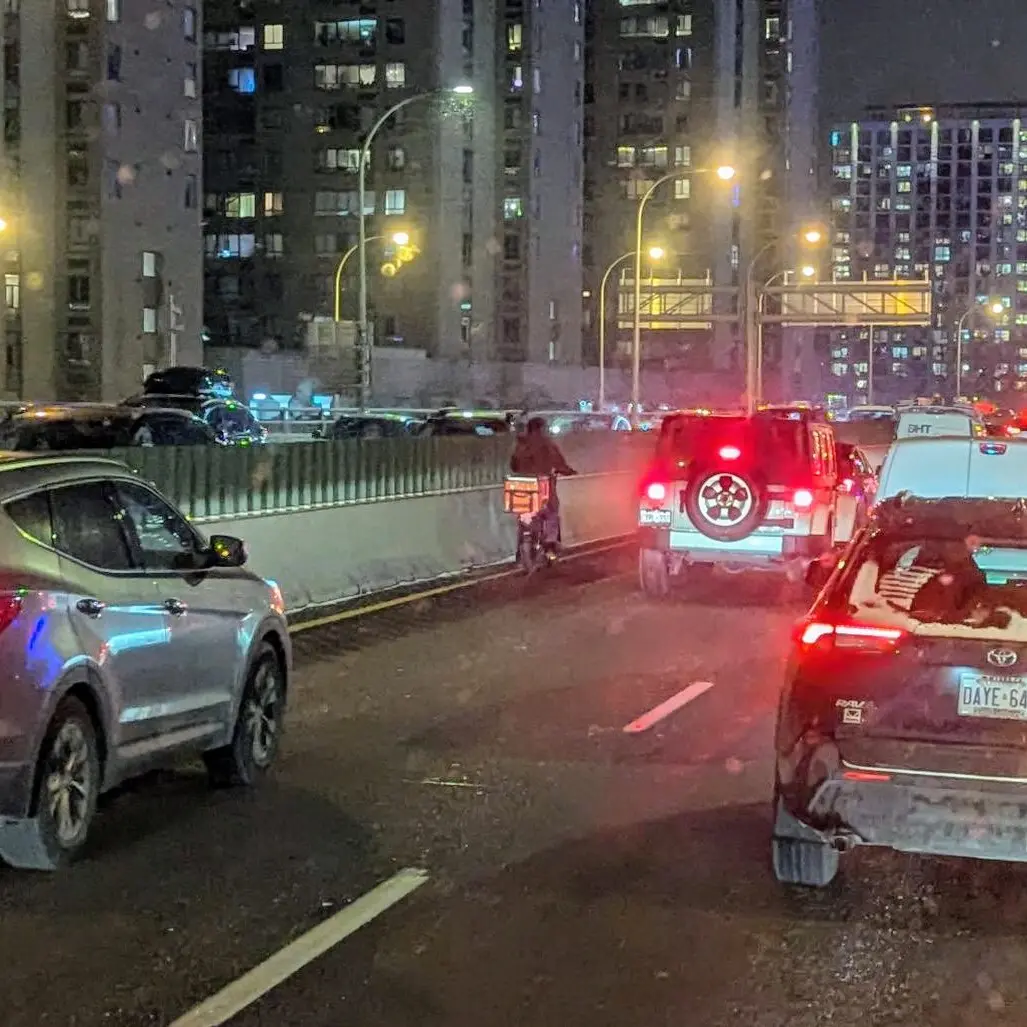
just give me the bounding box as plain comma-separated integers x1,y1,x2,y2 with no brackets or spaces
774,763,1027,863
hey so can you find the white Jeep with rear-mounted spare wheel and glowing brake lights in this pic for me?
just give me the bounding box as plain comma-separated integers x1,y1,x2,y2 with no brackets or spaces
639,407,852,597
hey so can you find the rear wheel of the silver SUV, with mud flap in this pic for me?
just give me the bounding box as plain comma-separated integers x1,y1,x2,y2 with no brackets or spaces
0,696,103,871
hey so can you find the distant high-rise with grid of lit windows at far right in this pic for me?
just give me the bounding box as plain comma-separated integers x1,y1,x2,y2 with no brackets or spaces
827,104,1027,401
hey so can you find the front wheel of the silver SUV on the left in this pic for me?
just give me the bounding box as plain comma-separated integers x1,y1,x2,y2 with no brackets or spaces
203,642,286,788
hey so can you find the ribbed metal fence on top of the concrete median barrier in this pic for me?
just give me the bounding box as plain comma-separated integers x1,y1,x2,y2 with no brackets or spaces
111,432,655,520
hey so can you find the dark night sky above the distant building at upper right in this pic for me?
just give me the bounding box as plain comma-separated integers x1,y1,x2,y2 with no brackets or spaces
821,0,1027,120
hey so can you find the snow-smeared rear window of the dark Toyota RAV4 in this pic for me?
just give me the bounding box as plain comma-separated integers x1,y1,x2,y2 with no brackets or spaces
845,532,1027,642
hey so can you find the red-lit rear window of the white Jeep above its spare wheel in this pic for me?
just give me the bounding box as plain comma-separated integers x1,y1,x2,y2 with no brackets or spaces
656,415,810,483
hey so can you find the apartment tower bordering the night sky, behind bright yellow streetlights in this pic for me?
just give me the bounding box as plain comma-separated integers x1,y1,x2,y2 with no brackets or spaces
585,0,796,382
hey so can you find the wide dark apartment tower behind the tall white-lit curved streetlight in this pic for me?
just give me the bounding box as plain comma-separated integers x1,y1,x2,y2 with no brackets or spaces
204,0,584,375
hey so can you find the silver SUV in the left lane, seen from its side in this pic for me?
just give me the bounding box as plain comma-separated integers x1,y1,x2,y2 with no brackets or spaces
0,454,292,870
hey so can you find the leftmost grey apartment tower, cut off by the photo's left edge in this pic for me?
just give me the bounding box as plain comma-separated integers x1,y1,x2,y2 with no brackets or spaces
8,0,202,400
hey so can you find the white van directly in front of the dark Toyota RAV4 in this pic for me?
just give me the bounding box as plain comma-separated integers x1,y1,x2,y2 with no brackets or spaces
877,438,1027,501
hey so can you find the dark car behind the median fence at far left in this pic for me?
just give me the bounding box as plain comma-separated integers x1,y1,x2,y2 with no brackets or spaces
0,404,218,452
